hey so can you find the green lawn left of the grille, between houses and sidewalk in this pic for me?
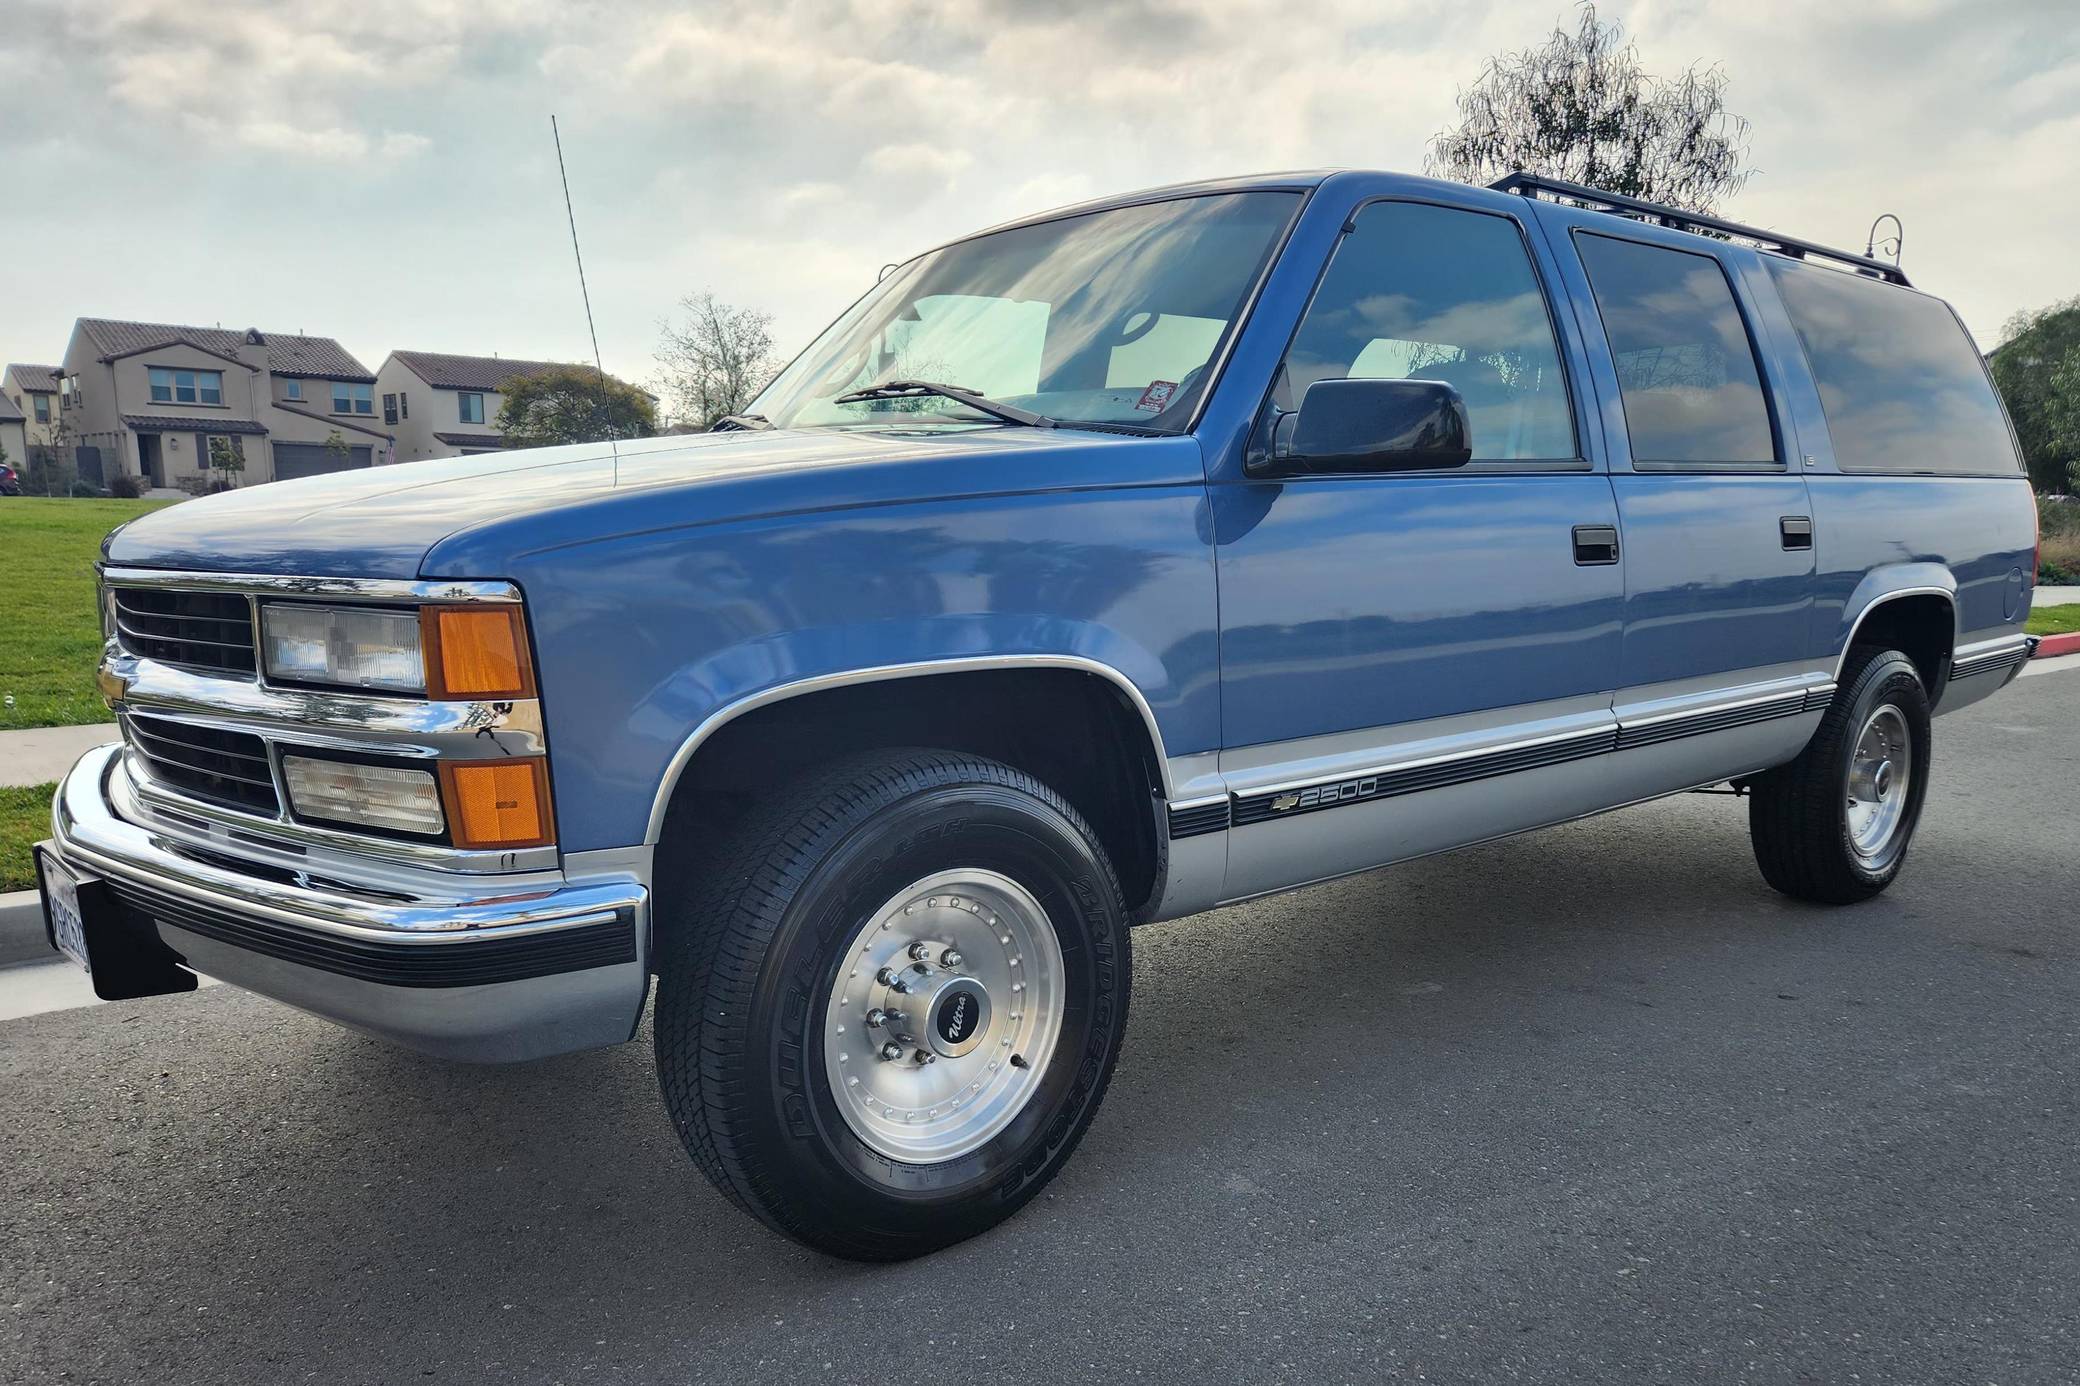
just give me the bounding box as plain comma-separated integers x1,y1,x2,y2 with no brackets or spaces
0,495,173,730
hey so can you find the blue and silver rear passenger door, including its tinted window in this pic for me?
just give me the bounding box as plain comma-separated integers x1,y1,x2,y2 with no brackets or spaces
1541,213,1826,778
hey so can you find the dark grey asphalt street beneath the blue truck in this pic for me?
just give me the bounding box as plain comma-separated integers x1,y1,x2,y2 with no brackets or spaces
0,672,2080,1386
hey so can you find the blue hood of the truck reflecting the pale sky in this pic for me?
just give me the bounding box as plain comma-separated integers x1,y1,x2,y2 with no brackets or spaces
102,427,1202,579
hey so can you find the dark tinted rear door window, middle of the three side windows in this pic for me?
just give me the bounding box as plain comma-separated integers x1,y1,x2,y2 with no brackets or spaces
1575,235,1776,464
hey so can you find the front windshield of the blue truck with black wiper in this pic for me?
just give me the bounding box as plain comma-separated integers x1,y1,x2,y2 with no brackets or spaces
751,191,1298,433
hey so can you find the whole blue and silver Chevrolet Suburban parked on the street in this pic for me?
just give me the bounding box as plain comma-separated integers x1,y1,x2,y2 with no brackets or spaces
37,173,2036,1259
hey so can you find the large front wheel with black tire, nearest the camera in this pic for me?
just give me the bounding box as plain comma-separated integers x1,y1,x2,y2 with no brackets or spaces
655,751,1129,1261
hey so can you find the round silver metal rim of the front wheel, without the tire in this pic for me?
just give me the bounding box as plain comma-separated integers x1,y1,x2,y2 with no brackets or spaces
824,868,1067,1163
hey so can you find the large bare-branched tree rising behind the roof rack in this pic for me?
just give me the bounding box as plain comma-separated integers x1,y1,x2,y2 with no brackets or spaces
1423,4,1749,212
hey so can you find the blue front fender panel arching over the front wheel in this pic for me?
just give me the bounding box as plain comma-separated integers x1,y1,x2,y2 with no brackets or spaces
484,483,1219,851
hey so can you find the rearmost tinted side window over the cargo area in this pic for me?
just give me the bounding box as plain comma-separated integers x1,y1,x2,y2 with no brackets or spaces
1770,258,2022,474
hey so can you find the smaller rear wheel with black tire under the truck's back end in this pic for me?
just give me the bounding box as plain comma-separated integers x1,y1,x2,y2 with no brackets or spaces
1747,645,1930,905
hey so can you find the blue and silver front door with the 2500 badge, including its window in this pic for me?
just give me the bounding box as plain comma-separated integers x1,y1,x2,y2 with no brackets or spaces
1213,200,1624,899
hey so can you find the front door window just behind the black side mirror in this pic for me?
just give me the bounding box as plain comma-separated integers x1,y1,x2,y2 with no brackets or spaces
1279,202,1577,462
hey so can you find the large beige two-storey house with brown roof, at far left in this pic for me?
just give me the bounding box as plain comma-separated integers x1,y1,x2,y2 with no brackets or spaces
58,318,393,487
